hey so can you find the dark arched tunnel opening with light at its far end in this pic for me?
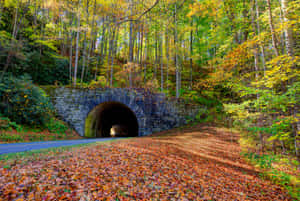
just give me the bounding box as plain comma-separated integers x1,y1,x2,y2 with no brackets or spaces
85,102,139,137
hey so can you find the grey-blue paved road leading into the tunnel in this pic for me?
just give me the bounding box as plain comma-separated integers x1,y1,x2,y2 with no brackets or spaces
0,138,120,154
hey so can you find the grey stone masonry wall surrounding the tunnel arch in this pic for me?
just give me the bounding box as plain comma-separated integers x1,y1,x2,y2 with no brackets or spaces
45,87,198,136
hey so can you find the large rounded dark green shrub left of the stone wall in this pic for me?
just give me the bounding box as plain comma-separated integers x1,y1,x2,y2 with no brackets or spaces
0,75,52,126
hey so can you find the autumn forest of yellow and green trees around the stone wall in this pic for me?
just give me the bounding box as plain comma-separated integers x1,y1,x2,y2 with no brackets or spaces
0,0,300,197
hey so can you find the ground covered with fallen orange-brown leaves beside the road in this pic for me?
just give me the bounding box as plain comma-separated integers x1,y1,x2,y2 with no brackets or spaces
0,126,291,201
